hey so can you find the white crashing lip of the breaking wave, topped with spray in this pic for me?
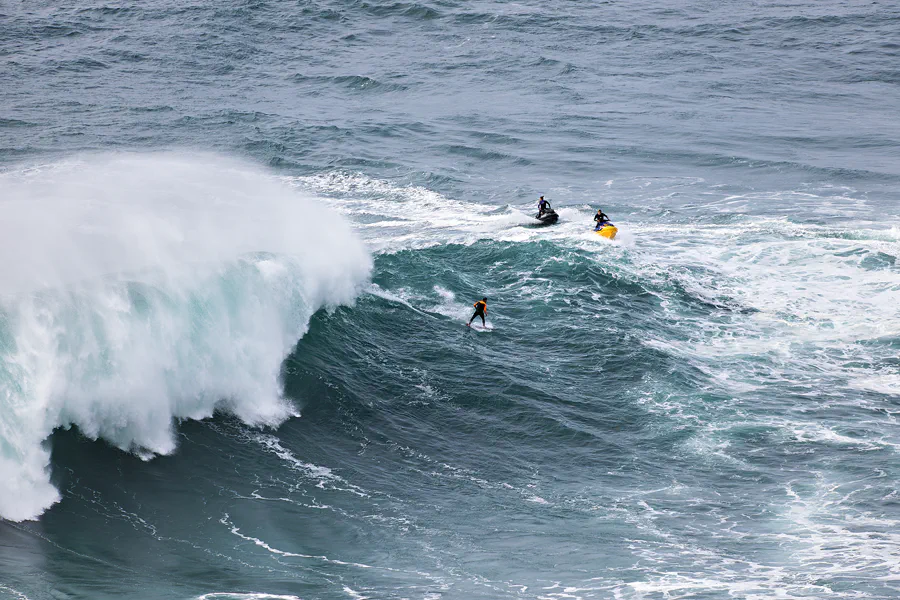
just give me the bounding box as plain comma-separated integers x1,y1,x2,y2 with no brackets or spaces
0,154,371,521
